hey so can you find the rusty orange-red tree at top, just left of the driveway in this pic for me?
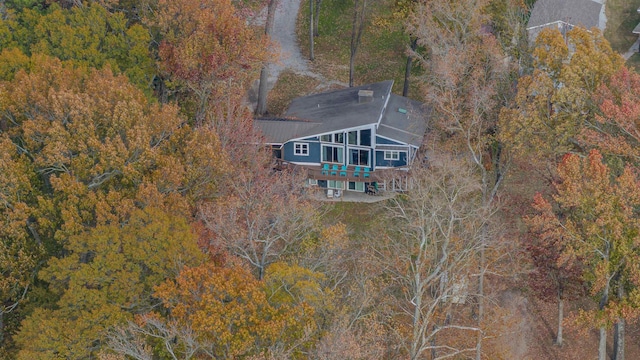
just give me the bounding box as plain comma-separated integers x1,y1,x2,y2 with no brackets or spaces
151,0,267,125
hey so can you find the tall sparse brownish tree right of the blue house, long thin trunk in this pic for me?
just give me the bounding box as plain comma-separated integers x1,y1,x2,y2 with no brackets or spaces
409,0,509,360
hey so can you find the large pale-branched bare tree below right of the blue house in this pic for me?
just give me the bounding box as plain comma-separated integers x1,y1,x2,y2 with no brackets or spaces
381,158,486,359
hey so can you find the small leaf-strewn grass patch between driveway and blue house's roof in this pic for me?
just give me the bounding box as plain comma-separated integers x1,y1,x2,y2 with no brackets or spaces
267,70,319,116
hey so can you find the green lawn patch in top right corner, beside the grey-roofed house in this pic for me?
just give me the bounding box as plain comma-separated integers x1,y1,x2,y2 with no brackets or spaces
604,0,640,53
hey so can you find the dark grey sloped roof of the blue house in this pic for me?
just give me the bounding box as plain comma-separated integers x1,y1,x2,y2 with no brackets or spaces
254,80,428,146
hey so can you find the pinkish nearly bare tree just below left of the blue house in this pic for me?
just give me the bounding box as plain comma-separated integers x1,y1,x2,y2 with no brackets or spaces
201,167,316,279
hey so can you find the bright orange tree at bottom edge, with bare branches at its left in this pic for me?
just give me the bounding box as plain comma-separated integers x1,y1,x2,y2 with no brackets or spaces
109,262,312,359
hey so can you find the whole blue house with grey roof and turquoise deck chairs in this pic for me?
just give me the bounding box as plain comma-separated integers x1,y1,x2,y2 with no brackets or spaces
254,80,429,192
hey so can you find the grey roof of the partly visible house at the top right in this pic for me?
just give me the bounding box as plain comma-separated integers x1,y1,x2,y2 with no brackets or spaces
527,0,602,30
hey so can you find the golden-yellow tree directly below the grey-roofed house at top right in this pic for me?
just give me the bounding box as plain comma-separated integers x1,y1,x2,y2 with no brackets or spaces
500,27,623,167
